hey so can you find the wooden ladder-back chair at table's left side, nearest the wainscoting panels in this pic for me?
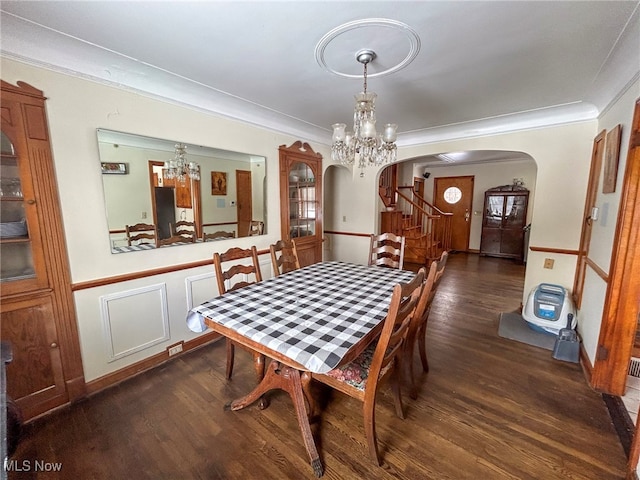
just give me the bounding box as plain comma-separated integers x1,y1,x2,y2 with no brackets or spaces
213,246,264,380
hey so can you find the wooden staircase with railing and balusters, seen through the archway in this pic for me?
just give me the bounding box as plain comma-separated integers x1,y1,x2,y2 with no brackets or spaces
379,185,452,265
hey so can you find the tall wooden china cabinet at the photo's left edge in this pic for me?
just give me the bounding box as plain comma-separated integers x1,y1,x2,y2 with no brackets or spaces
0,81,85,420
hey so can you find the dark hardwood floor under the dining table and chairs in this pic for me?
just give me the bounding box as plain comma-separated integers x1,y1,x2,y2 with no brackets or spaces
9,254,626,480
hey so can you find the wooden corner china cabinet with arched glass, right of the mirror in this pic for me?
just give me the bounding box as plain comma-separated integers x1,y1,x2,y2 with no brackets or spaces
279,141,322,267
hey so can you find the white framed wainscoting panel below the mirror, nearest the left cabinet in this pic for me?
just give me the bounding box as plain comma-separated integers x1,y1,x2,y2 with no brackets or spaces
100,283,170,362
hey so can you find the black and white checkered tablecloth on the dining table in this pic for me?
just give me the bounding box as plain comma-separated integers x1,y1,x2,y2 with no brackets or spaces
187,262,415,373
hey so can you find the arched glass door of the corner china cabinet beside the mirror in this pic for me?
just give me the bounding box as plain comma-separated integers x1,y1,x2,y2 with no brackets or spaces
289,162,317,238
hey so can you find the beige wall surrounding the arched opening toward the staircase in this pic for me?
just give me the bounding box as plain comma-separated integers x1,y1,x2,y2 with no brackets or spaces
325,120,597,301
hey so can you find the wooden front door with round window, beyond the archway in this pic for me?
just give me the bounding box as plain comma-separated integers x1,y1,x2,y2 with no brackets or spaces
433,176,474,252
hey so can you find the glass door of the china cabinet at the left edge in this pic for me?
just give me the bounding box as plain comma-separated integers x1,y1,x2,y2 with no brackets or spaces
0,132,36,284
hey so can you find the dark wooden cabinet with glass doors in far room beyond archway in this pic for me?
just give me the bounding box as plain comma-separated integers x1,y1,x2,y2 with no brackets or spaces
480,185,529,261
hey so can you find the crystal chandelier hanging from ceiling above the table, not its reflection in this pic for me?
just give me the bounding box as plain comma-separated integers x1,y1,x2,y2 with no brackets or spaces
331,50,398,177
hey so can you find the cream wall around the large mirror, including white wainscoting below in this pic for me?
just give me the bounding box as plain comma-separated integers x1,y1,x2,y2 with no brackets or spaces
0,58,329,381
